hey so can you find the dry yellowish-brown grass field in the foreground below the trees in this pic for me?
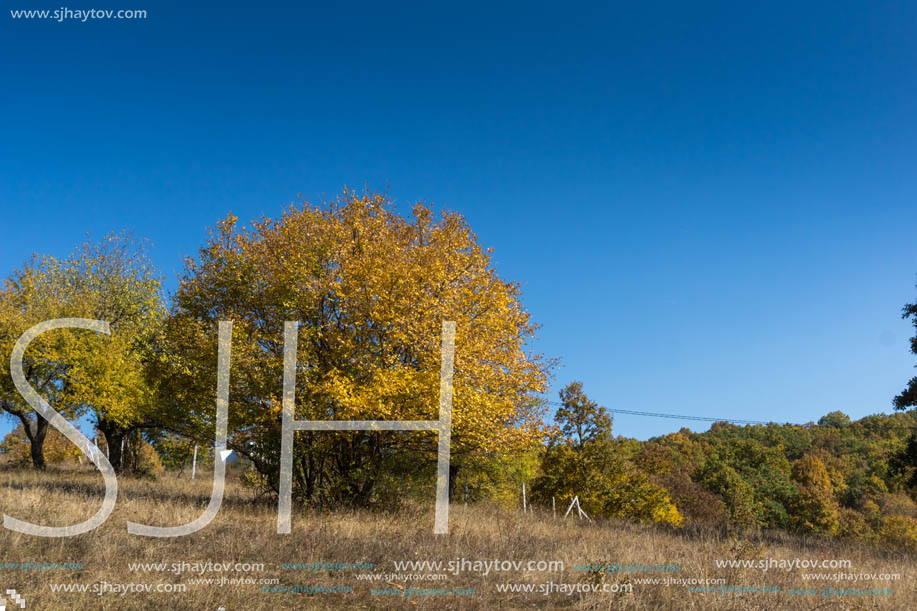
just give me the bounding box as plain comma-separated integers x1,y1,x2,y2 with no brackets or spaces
0,467,917,611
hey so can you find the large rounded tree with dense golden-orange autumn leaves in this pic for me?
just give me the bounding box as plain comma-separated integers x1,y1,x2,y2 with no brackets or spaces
160,190,549,505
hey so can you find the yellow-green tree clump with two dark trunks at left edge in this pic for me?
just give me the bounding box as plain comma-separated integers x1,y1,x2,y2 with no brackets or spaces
0,234,163,471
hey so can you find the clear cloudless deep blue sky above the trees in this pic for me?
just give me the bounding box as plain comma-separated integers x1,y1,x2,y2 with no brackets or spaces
0,0,917,438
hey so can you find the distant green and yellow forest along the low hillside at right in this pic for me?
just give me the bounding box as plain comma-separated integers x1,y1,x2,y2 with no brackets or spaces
536,392,917,551
